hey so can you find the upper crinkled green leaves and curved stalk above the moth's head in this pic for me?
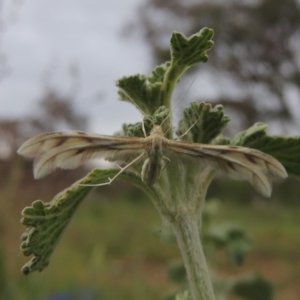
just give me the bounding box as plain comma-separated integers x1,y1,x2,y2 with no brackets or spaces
116,28,213,122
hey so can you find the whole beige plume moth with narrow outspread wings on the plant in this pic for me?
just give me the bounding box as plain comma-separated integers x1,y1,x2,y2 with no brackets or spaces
18,125,287,197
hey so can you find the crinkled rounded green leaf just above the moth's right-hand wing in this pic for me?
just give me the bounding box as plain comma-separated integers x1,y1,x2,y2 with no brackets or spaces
176,102,230,144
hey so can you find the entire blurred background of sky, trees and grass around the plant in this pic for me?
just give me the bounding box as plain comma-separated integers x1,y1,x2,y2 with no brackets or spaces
0,0,300,300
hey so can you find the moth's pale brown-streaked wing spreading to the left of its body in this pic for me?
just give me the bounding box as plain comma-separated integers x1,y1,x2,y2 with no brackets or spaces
17,131,144,178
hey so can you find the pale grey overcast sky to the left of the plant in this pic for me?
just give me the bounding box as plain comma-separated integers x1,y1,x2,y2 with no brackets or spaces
0,0,150,134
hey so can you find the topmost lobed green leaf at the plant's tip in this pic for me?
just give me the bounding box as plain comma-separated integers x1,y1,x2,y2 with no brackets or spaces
171,28,214,68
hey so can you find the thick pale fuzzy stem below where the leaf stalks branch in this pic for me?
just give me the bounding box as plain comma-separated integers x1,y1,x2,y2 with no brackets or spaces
172,215,215,300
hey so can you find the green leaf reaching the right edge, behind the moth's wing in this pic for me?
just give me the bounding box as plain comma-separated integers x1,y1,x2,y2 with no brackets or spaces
231,123,300,177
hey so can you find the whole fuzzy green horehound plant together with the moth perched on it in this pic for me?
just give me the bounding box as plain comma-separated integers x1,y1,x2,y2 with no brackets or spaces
18,28,299,300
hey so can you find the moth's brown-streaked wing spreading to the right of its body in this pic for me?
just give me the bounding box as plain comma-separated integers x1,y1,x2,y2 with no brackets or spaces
167,141,287,197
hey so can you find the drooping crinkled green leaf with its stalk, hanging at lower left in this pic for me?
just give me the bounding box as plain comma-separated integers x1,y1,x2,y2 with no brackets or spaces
21,169,155,275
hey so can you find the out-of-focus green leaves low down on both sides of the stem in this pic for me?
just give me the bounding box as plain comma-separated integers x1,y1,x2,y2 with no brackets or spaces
159,199,274,300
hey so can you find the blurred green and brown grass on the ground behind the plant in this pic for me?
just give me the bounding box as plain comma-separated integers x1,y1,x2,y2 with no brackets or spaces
0,184,300,300
